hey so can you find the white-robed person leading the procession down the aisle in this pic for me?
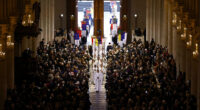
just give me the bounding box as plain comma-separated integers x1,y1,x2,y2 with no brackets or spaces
94,70,103,92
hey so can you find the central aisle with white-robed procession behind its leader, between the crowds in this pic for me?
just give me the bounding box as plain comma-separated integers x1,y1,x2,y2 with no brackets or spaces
89,40,107,110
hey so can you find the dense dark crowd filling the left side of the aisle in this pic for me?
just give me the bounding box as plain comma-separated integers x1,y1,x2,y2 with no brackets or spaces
5,38,90,110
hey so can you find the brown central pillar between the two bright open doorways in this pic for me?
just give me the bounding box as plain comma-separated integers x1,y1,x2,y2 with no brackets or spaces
94,0,103,36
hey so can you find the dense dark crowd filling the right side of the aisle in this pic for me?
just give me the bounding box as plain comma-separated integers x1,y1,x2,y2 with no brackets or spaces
105,40,196,110
